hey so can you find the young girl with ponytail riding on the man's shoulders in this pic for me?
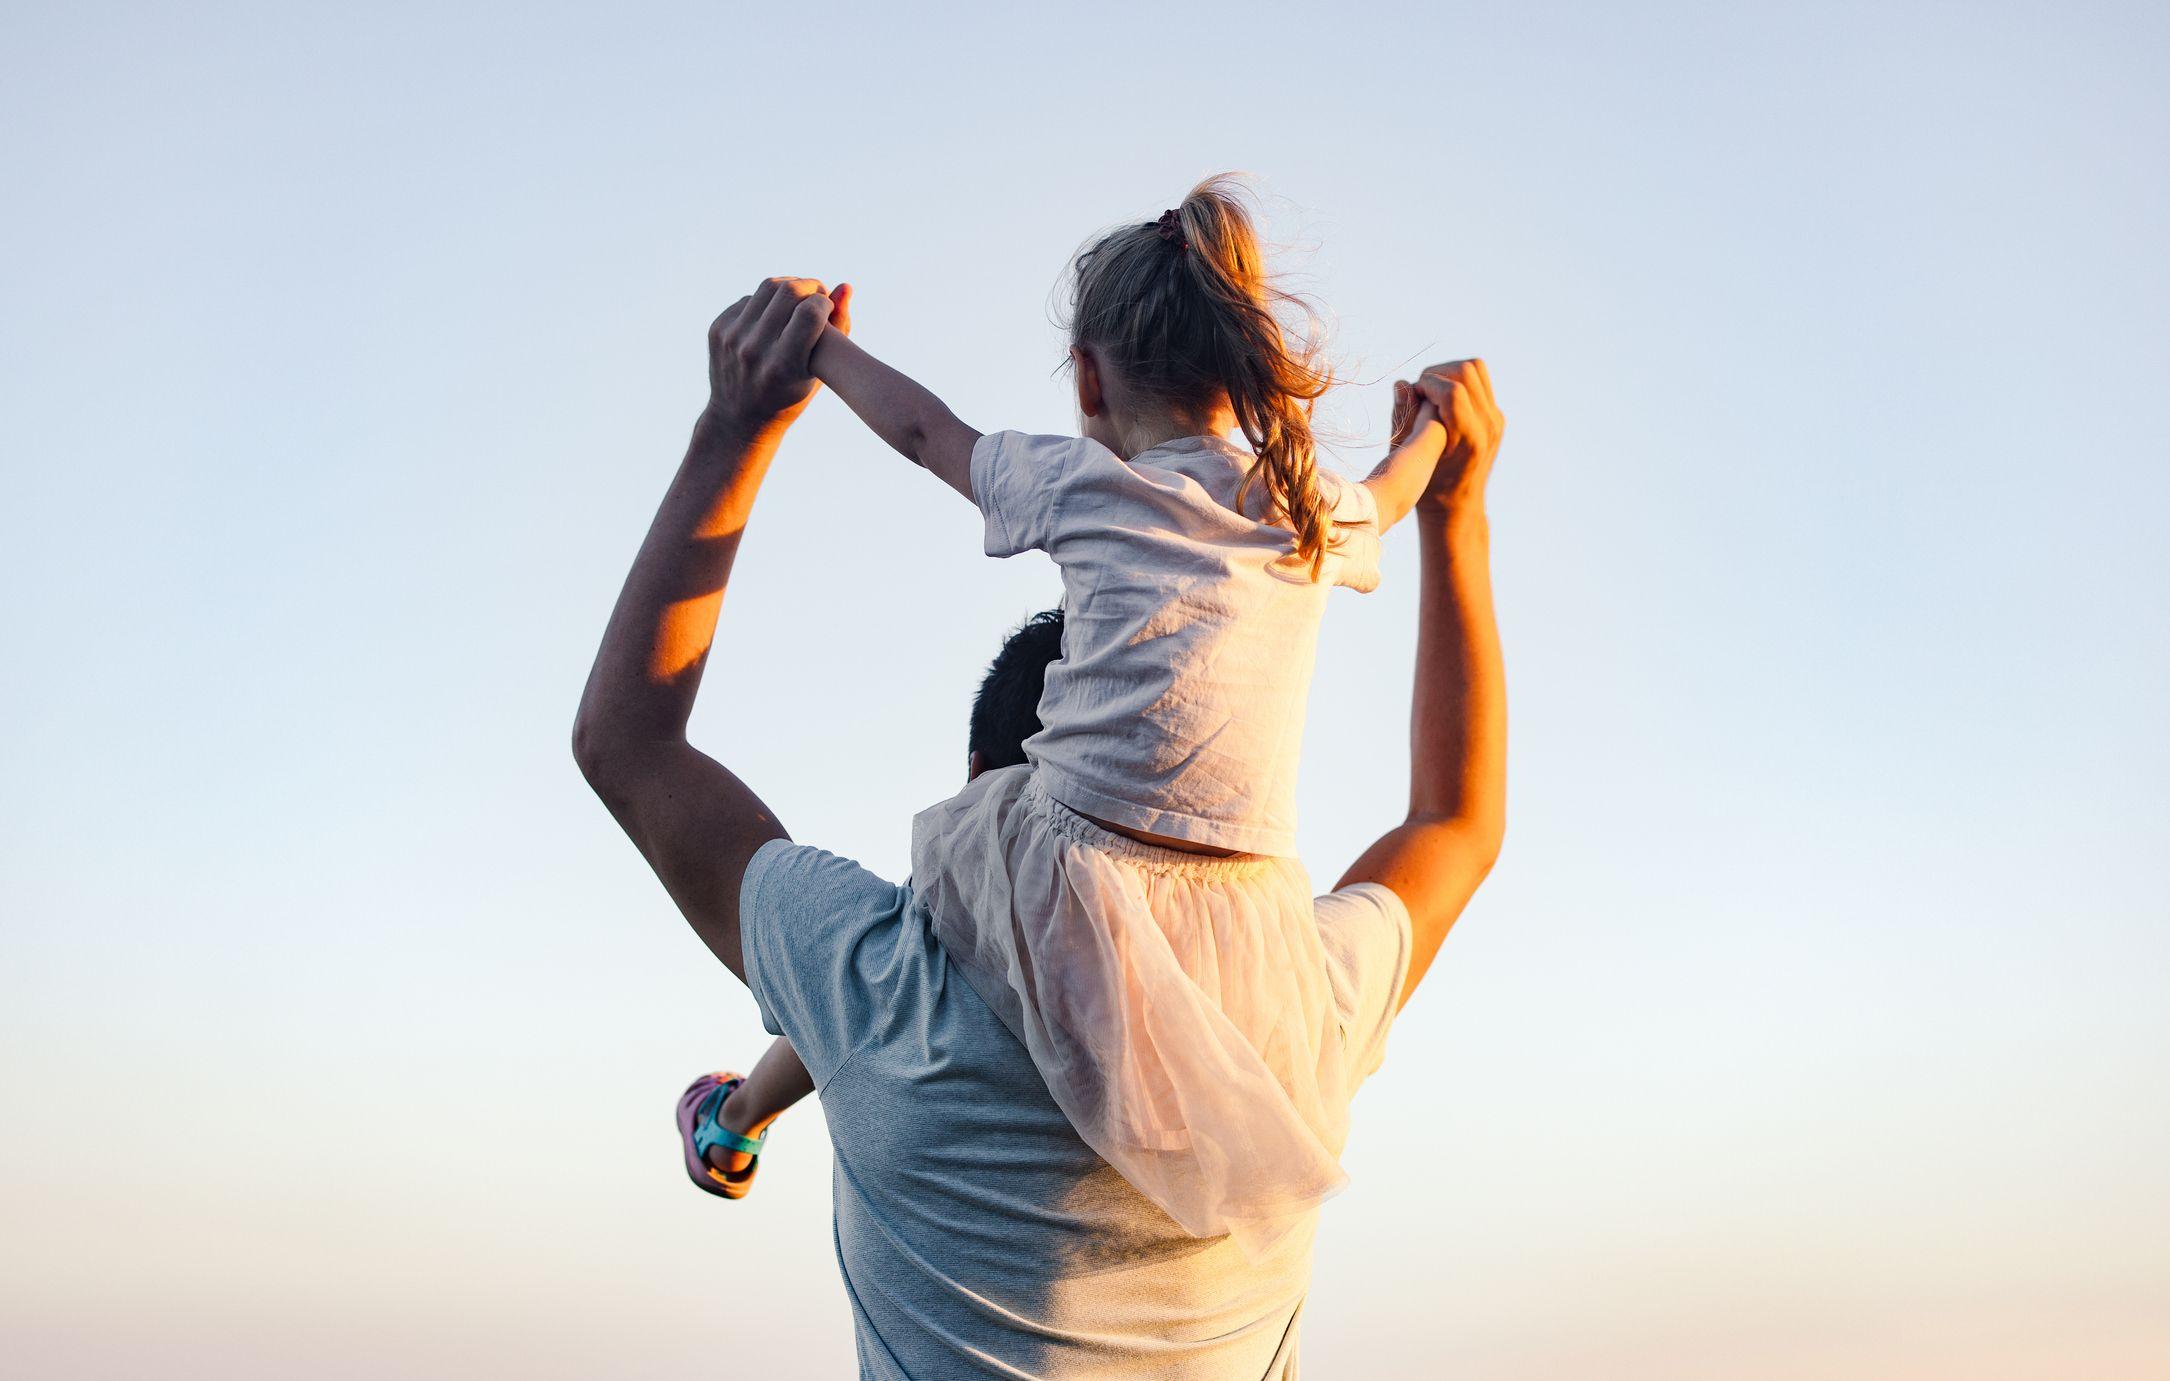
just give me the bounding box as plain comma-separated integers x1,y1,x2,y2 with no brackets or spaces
677,178,1445,1253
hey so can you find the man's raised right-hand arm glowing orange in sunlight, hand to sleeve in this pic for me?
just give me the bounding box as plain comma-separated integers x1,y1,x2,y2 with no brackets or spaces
1335,360,1506,1003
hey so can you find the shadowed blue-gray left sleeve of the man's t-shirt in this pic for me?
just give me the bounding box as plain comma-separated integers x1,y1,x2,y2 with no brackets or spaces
738,838,911,1088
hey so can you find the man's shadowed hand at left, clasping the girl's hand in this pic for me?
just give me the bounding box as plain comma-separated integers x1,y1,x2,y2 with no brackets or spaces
707,278,851,436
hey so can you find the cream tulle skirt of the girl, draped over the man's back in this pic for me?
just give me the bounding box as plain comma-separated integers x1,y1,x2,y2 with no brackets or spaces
911,766,1350,1255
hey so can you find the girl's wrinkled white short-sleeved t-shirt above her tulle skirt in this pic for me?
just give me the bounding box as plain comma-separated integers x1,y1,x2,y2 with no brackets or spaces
972,432,1378,856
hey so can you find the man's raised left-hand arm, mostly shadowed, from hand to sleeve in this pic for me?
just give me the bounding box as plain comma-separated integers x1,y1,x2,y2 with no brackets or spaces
573,278,846,979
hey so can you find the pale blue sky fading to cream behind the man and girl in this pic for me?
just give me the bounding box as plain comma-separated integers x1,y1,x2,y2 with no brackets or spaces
0,2,2170,1381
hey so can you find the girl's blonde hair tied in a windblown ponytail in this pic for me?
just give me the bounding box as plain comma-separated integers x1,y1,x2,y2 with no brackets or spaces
1070,174,1335,580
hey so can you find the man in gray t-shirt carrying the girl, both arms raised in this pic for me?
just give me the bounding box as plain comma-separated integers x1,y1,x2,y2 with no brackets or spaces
573,278,1506,1379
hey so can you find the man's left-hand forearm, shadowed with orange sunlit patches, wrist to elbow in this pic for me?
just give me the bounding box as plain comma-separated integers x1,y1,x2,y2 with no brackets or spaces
573,410,781,764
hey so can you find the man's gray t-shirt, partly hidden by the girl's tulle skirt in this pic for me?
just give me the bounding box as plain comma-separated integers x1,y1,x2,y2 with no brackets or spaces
740,840,1411,1381
